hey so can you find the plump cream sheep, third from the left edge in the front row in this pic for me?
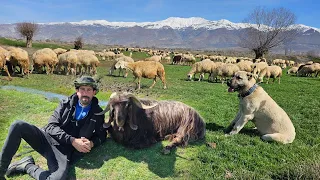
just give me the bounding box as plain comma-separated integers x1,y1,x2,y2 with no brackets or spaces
32,48,59,74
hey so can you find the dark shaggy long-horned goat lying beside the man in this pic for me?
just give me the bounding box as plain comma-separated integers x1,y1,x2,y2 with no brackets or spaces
99,93,205,154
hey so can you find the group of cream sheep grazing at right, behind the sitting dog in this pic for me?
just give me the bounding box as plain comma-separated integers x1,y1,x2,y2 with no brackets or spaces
188,56,320,84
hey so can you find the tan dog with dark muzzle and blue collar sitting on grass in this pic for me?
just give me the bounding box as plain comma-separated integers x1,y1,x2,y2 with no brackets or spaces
226,71,296,144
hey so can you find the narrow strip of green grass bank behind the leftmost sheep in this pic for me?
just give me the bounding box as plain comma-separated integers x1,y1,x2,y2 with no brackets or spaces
0,38,73,49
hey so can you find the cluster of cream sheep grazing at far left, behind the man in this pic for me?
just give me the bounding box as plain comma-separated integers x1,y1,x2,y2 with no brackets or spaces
0,47,100,79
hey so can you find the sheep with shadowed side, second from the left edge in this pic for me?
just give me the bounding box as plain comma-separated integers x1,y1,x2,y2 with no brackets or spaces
7,47,30,77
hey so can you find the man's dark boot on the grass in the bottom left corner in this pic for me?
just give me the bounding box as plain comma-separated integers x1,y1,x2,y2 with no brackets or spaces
6,156,35,177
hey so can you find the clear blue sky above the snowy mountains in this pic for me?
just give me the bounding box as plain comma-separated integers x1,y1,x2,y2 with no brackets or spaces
0,0,320,28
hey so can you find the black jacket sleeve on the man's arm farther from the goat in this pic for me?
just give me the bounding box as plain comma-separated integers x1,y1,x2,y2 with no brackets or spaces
44,98,74,144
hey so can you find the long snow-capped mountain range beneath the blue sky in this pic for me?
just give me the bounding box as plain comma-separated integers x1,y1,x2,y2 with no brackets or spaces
0,17,320,50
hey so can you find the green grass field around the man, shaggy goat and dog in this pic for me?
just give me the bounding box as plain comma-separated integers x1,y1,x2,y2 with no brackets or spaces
0,63,320,179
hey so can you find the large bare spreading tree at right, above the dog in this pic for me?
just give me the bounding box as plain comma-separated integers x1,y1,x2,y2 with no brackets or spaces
239,7,300,59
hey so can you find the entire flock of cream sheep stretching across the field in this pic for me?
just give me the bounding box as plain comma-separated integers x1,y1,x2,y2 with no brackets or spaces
0,47,320,89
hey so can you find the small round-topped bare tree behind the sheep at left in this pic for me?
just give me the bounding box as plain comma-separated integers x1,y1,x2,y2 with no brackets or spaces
16,22,39,47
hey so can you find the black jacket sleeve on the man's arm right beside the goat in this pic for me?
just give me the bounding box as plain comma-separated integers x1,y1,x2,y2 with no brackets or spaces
91,115,107,147
